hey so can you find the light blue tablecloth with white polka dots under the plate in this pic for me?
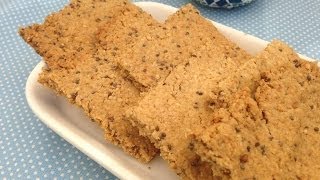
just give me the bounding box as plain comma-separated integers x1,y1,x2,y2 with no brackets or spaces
0,0,320,179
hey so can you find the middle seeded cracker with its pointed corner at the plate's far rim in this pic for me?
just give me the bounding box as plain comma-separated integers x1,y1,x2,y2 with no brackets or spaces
98,4,250,90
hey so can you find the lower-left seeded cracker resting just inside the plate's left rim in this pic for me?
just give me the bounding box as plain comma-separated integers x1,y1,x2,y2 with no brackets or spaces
39,60,158,162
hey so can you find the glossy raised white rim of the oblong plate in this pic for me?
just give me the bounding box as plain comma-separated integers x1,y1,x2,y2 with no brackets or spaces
25,1,320,180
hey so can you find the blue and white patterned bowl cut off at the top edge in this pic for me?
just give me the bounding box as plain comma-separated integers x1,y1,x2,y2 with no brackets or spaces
195,0,253,9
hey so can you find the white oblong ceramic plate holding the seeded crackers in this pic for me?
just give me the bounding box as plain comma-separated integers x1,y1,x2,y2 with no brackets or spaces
26,2,318,180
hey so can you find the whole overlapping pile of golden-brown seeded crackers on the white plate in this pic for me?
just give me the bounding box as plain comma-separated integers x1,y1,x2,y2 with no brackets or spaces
20,0,320,179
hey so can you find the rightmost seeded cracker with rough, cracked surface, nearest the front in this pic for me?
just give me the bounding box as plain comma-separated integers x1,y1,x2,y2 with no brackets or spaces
190,41,320,179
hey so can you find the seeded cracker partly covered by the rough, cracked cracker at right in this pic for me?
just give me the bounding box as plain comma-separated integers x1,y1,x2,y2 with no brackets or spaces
128,46,242,179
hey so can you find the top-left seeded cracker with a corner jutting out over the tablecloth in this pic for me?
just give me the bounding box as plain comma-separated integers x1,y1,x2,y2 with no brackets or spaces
19,0,129,68
